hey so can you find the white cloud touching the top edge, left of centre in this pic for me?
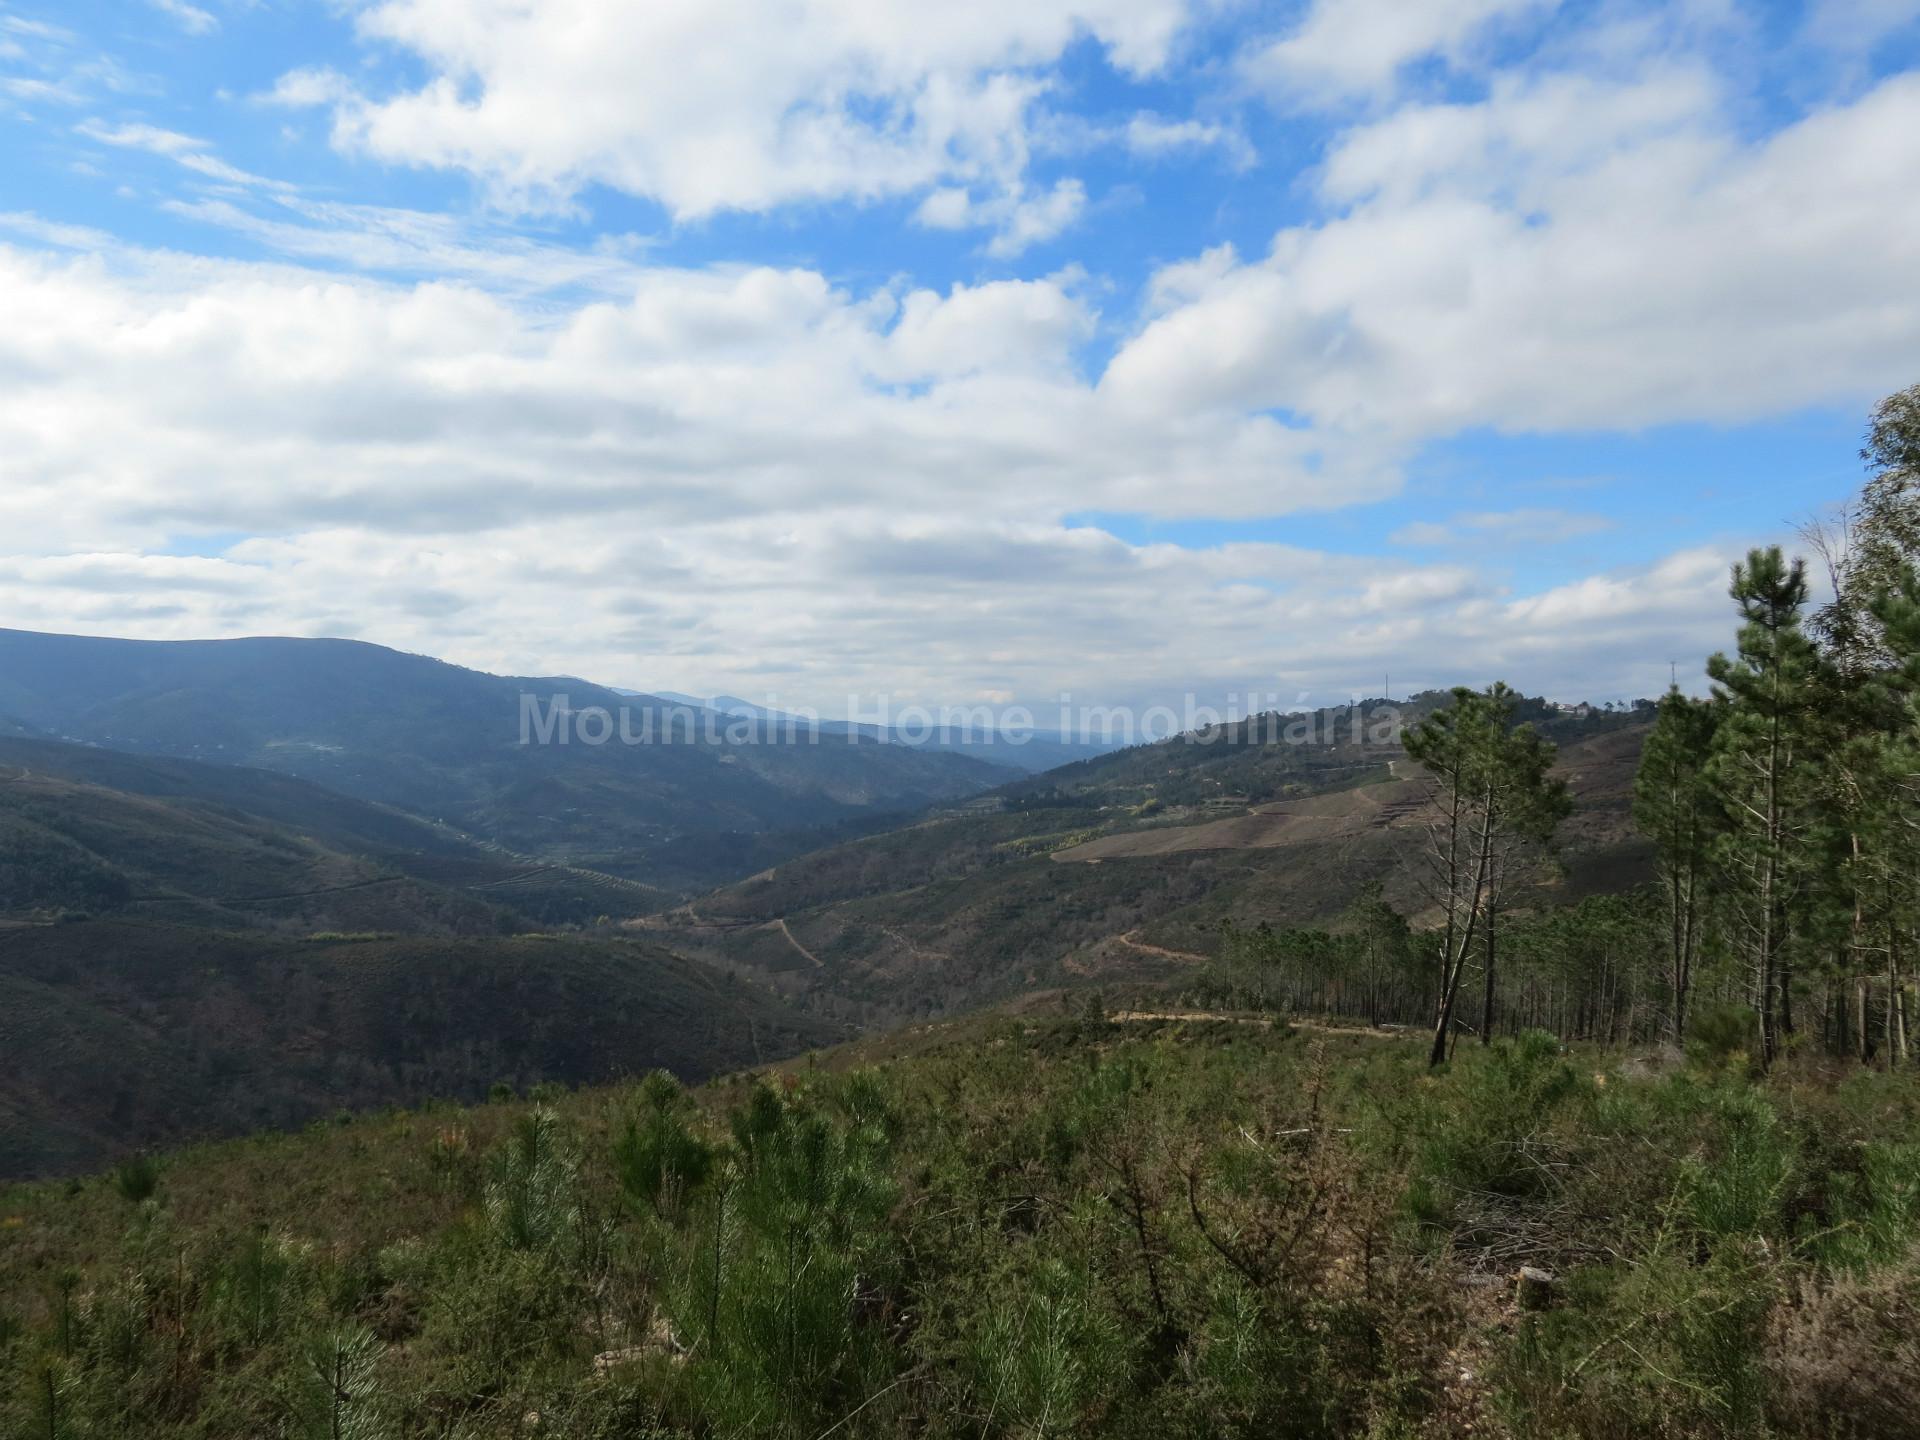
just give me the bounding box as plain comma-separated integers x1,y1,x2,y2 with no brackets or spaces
275,0,1190,234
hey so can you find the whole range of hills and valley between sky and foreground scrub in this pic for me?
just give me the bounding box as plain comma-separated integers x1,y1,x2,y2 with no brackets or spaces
0,632,1647,1175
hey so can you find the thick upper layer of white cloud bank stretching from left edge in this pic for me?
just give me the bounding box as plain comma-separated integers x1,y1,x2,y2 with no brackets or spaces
0,240,1367,545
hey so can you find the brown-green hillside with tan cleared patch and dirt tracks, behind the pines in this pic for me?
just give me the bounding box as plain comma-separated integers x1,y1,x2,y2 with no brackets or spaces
634,703,1649,1021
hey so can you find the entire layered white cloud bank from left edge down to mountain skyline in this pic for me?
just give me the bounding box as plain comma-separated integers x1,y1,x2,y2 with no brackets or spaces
0,235,1720,707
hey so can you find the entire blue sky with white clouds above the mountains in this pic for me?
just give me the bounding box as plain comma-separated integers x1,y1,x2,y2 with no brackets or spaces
0,0,1920,712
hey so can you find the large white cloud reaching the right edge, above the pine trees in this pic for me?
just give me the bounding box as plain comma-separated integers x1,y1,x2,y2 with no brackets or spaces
1102,71,1920,442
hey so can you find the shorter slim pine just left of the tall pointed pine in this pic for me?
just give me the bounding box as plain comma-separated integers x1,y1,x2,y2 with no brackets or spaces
1634,685,1724,1044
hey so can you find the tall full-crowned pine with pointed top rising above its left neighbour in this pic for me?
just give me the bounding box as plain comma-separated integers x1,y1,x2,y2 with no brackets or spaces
1707,545,1818,1064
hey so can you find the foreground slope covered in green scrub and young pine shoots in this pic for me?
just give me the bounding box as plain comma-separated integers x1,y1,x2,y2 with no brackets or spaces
0,1012,1920,1440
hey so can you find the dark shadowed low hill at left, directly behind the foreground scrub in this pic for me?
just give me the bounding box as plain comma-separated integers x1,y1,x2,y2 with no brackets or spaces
0,922,839,1175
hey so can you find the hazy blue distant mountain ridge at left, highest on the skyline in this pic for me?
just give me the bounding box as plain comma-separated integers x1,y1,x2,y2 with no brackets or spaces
0,630,1010,889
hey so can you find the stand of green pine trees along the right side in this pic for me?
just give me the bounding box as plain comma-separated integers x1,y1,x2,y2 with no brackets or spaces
1196,386,1920,1068
